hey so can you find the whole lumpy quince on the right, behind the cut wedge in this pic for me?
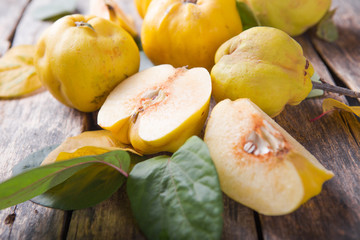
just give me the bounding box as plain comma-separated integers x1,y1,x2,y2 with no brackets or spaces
211,27,314,117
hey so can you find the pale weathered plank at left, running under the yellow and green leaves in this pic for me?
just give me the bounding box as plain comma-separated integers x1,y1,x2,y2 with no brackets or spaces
0,0,88,239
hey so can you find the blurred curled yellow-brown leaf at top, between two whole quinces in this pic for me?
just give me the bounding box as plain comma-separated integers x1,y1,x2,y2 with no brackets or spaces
90,0,138,37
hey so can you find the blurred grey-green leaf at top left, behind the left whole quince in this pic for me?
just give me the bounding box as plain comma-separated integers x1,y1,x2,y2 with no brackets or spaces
32,0,76,21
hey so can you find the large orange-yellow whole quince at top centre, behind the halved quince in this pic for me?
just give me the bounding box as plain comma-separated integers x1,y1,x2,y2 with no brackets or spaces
141,0,242,70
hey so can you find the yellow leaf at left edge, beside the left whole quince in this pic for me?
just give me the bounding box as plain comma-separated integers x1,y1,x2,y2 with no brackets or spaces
0,45,42,98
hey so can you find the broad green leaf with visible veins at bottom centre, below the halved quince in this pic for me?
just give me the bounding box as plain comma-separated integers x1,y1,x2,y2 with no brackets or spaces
127,136,223,239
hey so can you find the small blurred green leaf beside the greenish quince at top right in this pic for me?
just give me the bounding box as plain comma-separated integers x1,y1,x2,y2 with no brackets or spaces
316,9,339,42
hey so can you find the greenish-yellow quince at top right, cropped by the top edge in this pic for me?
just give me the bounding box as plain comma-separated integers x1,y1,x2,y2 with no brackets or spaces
241,0,331,36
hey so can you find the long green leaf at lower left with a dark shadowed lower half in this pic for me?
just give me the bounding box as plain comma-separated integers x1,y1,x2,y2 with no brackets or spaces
0,150,130,210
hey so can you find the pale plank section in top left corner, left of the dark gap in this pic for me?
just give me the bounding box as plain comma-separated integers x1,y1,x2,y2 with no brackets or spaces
0,0,29,56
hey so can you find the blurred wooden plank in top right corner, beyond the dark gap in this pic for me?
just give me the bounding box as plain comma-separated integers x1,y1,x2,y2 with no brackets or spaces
312,0,360,91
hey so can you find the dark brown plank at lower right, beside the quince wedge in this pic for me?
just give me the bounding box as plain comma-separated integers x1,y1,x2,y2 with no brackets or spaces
260,38,360,239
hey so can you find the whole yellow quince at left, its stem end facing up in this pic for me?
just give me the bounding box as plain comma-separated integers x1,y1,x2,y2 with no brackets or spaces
35,14,140,112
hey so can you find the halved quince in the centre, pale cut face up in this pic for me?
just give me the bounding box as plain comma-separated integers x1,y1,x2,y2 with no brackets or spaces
98,64,211,154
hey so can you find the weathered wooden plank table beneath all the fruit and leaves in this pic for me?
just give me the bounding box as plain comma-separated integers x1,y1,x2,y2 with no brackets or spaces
0,0,360,240
